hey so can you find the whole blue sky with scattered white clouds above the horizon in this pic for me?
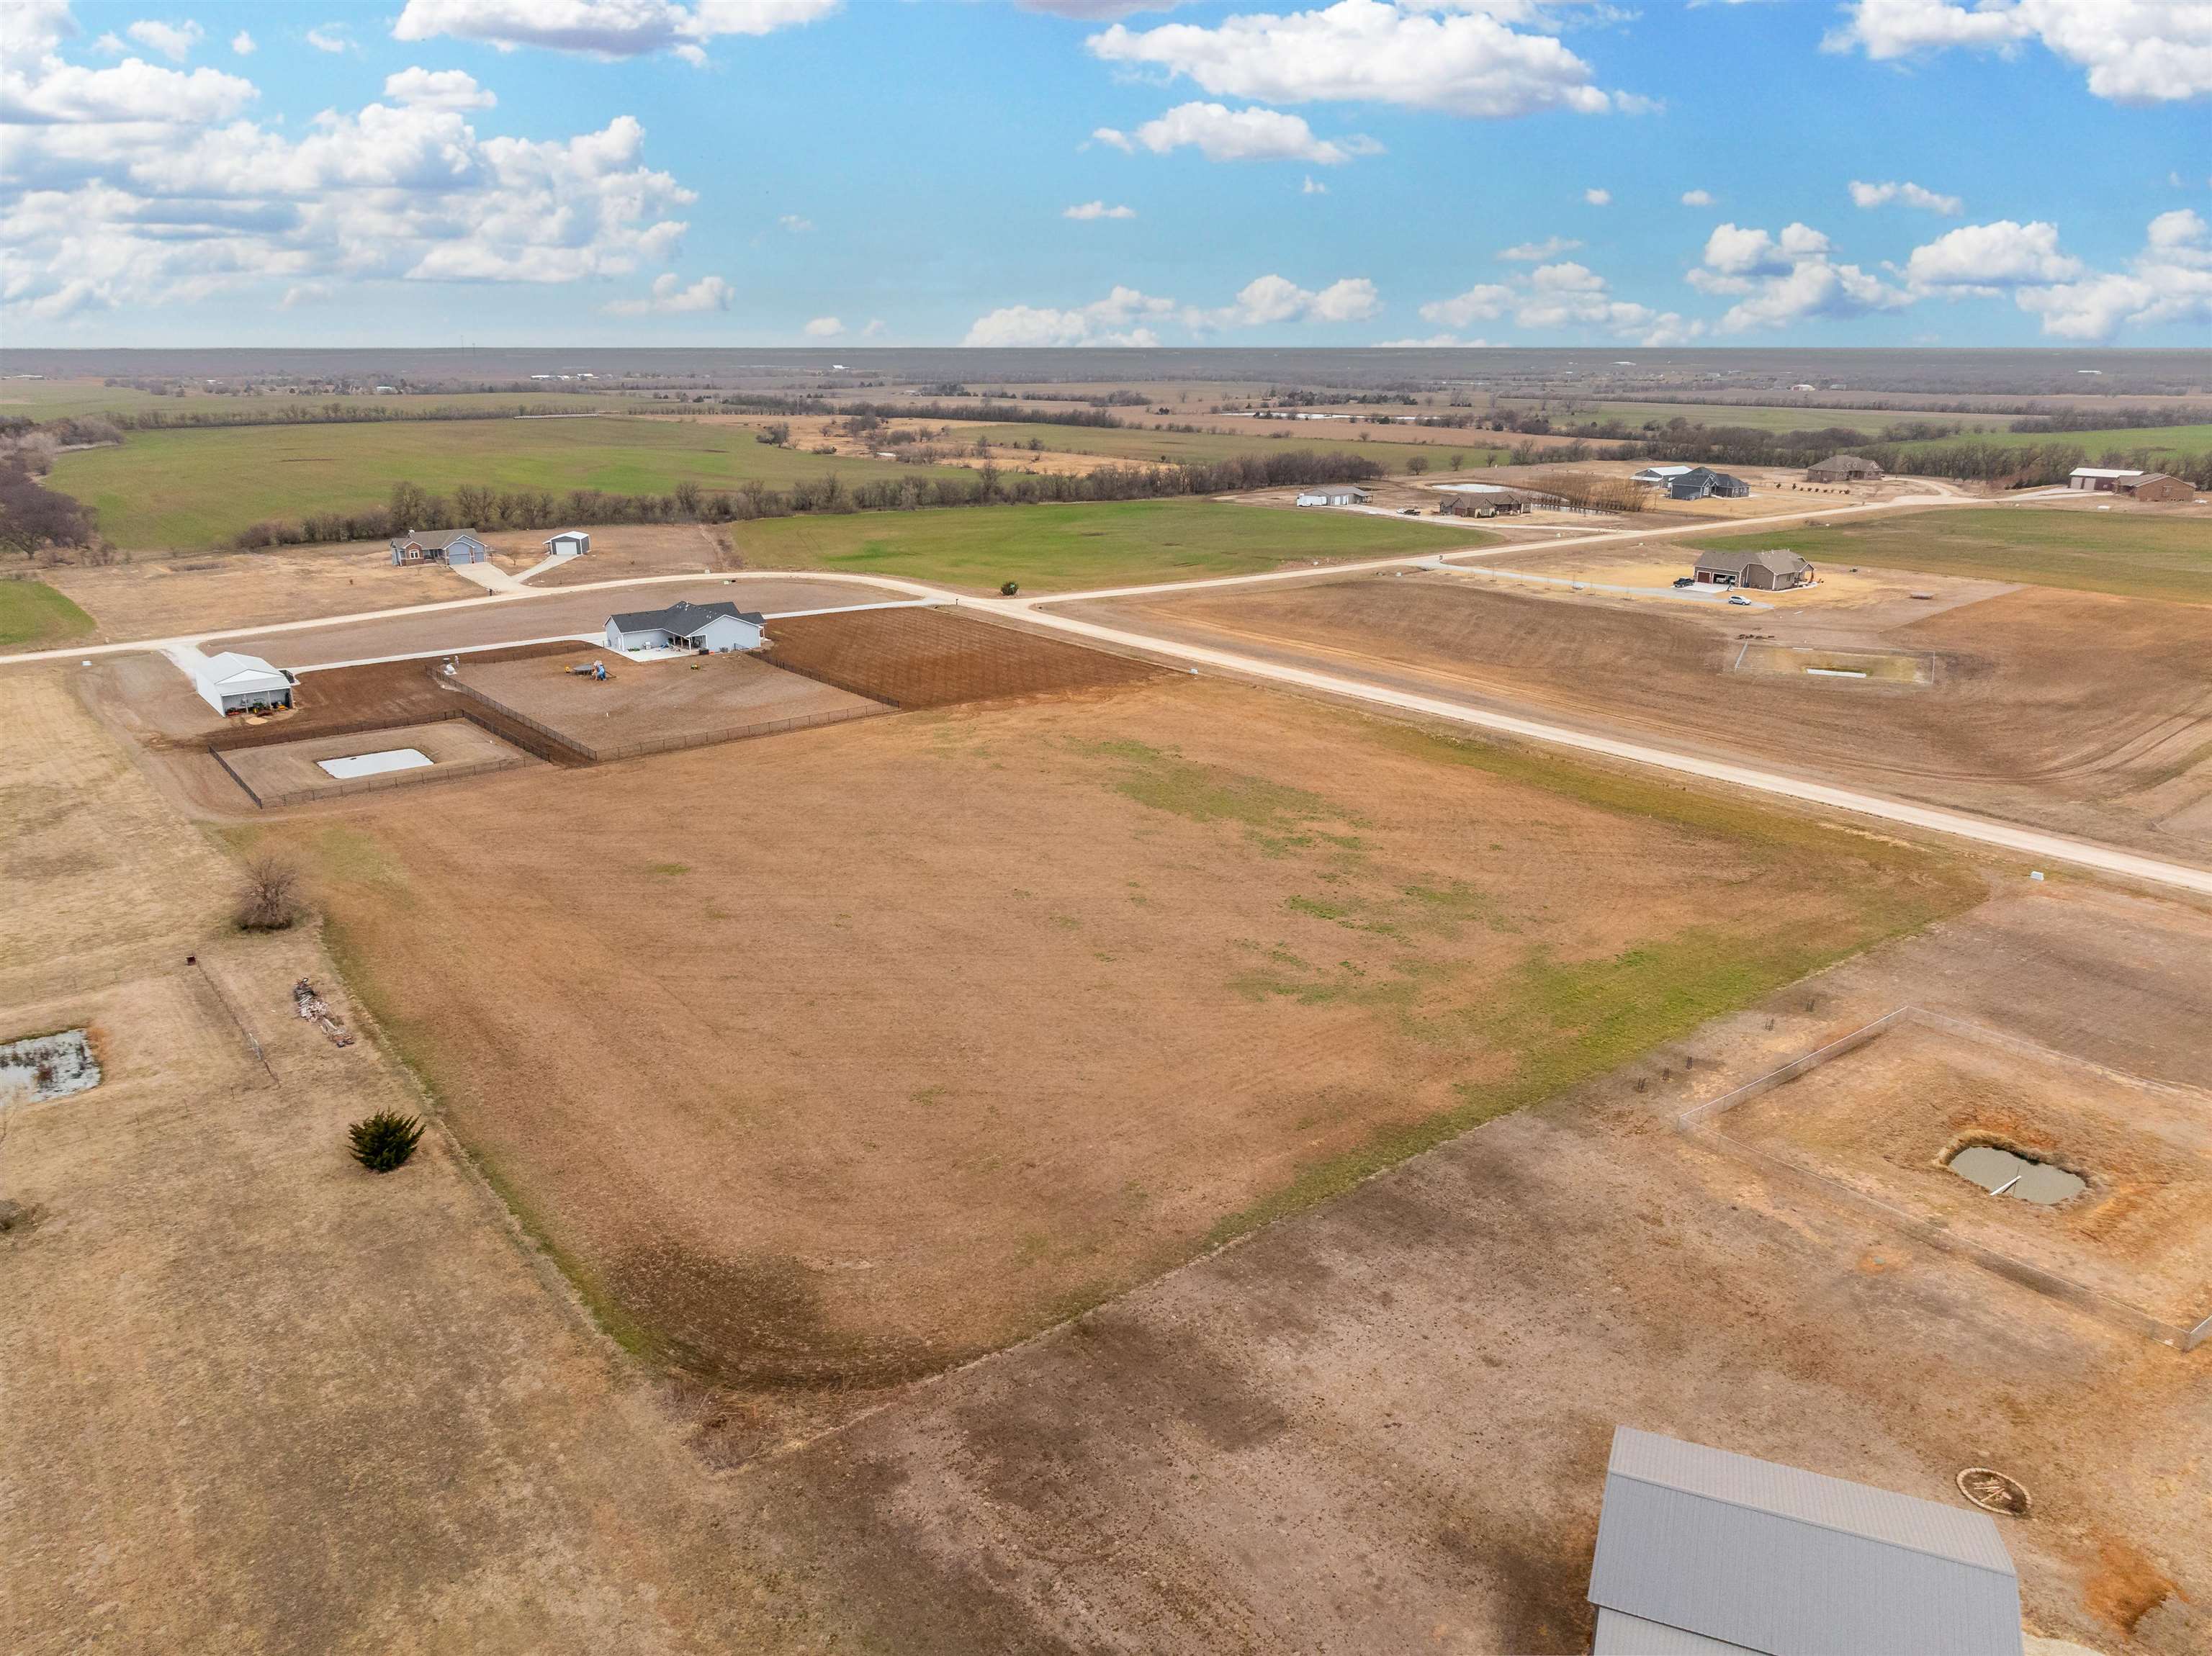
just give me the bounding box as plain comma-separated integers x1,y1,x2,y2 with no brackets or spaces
0,0,2212,347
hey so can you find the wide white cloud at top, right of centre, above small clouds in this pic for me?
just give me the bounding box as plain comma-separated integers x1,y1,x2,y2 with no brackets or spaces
1086,0,1615,117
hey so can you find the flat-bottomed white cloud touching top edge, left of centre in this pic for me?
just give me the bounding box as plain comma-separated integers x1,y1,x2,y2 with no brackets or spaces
392,0,838,62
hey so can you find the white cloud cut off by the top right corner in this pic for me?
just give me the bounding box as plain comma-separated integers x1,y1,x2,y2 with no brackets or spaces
1822,0,2212,104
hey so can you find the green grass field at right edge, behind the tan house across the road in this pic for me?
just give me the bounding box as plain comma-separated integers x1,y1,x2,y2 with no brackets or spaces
1694,506,2212,603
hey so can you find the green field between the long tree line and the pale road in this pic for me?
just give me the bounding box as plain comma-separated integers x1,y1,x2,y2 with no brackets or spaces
732,500,1496,593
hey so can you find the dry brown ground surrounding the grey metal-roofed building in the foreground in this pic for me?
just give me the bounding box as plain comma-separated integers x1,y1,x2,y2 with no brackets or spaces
741,882,2212,1656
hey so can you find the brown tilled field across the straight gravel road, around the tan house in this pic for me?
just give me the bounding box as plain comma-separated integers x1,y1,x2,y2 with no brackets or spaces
1097,575,2212,855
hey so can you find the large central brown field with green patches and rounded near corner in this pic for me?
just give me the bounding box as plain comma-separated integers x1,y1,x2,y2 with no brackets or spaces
261,681,1982,1431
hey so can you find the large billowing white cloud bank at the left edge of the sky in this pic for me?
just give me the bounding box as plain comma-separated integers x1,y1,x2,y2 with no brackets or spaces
0,35,714,320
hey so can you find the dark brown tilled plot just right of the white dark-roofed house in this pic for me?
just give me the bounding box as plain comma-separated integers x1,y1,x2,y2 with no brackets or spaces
768,611,1166,708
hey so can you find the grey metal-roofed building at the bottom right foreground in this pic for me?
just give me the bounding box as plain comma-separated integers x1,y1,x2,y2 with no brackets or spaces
1591,1426,2024,1656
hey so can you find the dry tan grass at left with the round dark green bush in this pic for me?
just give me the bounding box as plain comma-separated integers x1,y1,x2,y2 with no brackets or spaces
0,670,832,1656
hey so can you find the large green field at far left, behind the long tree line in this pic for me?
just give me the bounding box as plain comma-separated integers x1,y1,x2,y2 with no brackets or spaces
53,415,964,551
